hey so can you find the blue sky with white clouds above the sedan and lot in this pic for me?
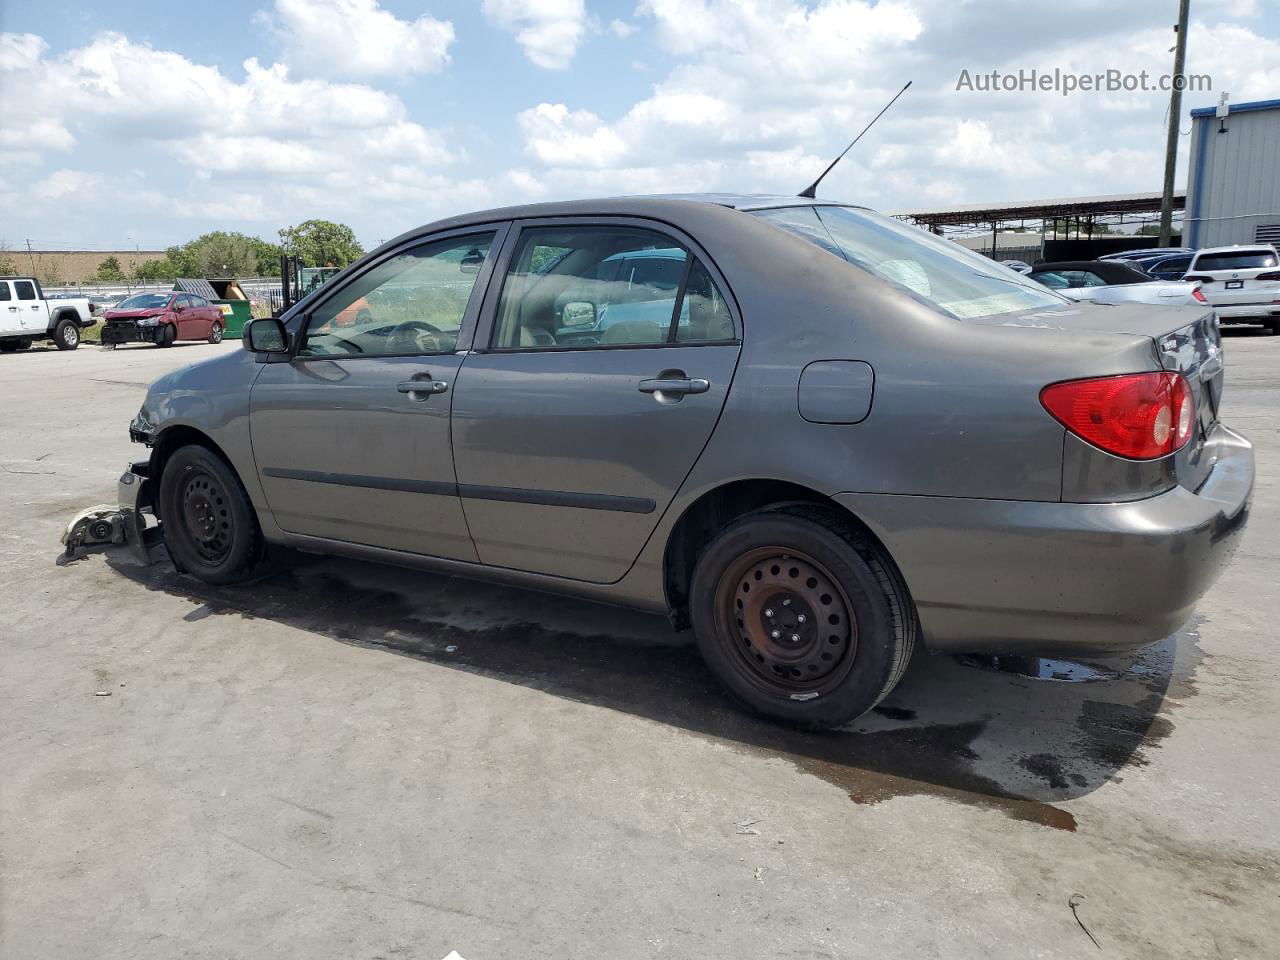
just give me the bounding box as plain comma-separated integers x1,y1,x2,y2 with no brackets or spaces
0,0,1280,250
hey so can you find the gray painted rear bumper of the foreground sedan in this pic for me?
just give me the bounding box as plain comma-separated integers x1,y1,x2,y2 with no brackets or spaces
836,425,1253,655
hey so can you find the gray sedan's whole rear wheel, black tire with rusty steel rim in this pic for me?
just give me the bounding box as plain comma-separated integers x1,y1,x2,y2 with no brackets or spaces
690,504,919,730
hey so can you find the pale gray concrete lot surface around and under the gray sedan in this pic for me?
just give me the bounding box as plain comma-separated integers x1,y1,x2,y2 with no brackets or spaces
0,330,1280,960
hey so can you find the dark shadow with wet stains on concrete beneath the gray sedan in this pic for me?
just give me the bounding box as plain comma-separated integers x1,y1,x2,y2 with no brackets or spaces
106,548,1198,829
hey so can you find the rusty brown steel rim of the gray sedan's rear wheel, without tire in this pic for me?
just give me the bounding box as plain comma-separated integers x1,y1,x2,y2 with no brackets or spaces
716,547,858,699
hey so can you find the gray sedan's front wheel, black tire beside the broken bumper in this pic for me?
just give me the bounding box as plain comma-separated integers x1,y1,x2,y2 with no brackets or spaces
160,445,265,584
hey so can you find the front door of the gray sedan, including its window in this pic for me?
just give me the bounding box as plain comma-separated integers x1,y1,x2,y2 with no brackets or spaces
250,224,504,561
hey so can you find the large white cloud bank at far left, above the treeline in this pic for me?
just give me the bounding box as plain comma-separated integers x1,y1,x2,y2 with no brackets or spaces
0,33,476,240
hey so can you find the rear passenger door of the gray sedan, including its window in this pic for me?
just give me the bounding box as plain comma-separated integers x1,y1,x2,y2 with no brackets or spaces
453,219,741,582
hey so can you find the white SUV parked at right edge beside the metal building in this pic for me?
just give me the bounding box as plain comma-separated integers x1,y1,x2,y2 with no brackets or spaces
1184,243,1280,334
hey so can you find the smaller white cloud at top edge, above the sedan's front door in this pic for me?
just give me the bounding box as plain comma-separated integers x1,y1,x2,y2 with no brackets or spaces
259,0,453,78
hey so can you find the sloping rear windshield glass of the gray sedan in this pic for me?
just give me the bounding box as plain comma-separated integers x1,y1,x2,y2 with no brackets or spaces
754,206,1071,320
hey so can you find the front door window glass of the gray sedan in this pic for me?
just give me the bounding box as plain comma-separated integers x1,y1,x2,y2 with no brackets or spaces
298,233,494,358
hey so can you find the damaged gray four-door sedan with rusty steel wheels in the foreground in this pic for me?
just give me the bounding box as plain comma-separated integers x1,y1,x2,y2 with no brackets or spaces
110,195,1253,727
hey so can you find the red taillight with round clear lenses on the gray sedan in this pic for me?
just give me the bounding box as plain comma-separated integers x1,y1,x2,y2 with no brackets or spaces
1041,371,1196,460
